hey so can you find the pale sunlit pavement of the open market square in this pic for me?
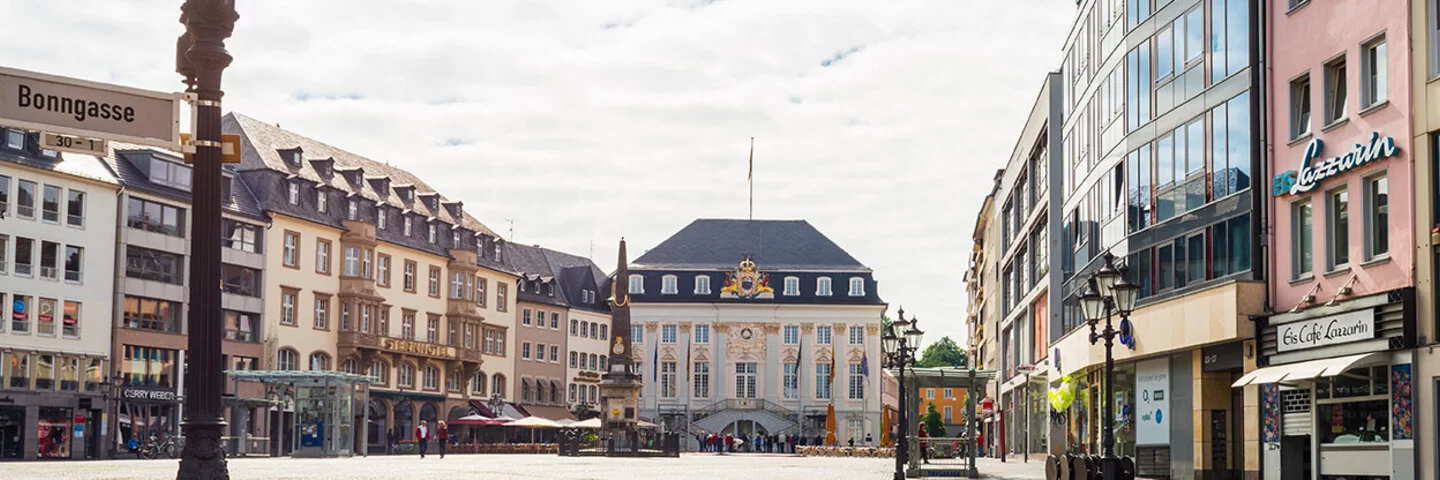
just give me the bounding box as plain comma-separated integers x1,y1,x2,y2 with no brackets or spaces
0,454,1045,480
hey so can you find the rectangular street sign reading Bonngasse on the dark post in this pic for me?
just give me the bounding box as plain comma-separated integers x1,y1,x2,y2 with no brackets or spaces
0,66,186,150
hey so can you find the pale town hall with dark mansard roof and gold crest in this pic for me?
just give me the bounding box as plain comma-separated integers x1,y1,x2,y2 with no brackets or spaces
626,219,887,444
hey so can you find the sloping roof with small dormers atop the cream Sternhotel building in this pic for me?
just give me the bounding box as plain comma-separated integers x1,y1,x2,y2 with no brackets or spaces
222,112,498,236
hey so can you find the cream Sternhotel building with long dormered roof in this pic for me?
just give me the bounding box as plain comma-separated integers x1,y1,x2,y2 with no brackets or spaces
223,112,520,454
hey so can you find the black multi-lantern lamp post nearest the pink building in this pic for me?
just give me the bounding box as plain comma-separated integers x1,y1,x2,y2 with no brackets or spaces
1080,252,1140,480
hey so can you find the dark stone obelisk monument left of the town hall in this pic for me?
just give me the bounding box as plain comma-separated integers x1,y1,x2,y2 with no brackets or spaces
600,238,644,455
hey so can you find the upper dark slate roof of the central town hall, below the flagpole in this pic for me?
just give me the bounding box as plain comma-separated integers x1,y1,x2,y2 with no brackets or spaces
631,219,870,271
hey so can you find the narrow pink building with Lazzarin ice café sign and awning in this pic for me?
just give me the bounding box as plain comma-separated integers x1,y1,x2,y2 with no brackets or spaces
1236,0,1418,480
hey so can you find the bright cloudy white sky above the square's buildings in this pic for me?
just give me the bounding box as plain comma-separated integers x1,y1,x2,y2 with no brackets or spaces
0,0,1074,342
